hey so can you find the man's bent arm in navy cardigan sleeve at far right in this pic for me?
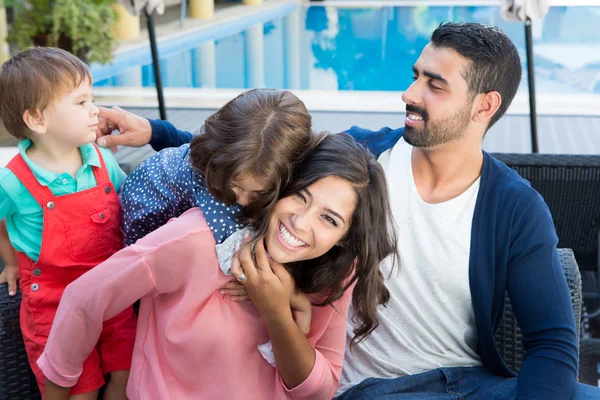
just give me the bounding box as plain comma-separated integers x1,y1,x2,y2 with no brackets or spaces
507,195,578,399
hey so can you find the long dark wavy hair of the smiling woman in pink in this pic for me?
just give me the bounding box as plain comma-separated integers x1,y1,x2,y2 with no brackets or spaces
250,133,398,344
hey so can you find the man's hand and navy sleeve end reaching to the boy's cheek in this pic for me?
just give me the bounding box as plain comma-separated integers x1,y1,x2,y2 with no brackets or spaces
96,107,193,151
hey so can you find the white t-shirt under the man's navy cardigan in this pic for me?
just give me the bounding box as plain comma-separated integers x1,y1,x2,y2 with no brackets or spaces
338,139,481,394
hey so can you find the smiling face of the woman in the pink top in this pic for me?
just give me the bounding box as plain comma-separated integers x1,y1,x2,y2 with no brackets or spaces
265,176,357,264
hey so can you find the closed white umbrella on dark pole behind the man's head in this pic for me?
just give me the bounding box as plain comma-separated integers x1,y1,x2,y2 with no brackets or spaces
501,0,550,153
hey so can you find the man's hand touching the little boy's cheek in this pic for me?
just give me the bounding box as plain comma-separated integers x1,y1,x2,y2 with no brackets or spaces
96,107,152,152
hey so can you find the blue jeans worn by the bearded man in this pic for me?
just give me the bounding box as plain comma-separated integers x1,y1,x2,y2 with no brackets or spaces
336,367,600,400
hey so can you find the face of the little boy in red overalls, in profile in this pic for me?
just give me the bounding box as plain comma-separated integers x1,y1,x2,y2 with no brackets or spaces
43,81,98,147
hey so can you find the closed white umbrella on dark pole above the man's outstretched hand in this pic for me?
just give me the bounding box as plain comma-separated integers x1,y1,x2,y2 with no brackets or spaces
119,0,167,120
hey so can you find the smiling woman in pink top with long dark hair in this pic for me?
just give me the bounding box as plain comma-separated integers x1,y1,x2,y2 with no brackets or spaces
38,134,395,400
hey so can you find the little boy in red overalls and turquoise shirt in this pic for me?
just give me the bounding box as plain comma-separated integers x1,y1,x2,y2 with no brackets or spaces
0,47,136,400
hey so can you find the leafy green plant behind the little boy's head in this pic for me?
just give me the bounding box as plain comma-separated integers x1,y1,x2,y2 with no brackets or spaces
6,0,117,64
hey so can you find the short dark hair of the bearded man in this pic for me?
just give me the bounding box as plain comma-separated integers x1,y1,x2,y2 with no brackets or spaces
431,22,522,129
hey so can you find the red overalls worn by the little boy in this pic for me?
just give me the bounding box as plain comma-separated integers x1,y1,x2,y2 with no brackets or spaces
7,148,136,395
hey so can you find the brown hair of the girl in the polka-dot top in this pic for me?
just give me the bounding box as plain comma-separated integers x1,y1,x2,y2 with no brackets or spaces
190,89,312,215
